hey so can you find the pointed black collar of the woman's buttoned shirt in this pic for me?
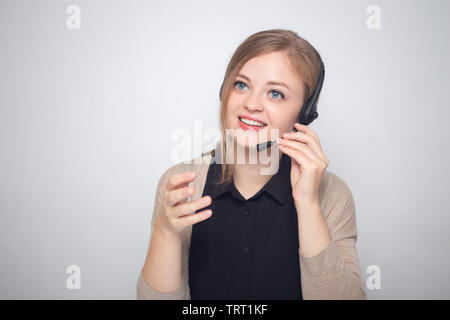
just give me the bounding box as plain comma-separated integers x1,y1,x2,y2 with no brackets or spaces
211,153,292,204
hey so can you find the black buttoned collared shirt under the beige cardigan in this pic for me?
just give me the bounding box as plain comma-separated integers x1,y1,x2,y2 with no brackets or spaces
189,154,302,300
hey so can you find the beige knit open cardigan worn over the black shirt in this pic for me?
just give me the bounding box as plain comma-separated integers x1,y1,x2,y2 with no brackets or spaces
136,153,366,300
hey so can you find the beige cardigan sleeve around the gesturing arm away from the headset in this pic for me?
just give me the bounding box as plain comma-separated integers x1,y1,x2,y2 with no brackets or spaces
136,164,190,300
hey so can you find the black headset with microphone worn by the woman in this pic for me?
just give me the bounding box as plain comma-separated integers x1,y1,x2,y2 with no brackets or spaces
219,55,325,152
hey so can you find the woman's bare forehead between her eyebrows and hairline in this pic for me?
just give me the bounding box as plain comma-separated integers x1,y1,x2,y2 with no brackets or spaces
238,52,302,90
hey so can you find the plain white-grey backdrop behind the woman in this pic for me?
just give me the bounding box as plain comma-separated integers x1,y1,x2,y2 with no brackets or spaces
0,0,450,299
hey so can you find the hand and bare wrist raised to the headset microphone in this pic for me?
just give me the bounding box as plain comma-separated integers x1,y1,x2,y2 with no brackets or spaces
278,123,329,206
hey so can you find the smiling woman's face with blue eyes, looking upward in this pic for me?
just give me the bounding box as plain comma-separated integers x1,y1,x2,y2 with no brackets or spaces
226,52,304,148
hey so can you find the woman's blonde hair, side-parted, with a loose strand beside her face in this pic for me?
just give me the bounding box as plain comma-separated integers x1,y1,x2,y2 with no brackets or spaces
213,29,320,184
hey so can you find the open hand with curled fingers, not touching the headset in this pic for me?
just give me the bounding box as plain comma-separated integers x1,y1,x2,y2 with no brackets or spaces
155,171,212,236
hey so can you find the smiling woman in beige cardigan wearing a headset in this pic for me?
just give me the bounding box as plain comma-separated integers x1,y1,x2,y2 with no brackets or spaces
137,29,366,299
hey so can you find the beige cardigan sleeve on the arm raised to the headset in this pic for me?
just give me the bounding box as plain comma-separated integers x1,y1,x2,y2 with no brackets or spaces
299,171,367,300
